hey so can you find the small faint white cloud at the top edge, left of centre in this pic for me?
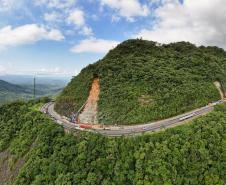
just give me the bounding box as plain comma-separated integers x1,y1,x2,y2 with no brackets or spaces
35,0,76,9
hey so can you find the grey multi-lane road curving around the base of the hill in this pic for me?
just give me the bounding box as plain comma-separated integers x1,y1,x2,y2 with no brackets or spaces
41,100,223,136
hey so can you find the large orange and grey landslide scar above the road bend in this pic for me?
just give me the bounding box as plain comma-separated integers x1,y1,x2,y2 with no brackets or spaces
79,78,100,124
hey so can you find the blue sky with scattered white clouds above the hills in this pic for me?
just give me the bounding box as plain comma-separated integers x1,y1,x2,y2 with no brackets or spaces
0,0,226,76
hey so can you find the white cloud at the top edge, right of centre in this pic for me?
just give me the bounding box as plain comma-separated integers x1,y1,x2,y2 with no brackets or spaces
100,0,149,21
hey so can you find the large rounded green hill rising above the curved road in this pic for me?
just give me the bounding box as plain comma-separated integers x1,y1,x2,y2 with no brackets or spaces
56,40,226,124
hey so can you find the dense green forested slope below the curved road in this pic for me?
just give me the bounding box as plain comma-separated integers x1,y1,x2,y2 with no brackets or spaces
0,102,226,185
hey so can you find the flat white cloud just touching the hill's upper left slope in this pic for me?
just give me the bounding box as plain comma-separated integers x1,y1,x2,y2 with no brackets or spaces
71,38,119,53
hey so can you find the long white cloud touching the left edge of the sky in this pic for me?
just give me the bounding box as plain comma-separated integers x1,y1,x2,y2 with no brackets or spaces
0,24,64,48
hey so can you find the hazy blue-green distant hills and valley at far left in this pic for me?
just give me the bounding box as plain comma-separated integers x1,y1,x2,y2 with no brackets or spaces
0,75,69,105
